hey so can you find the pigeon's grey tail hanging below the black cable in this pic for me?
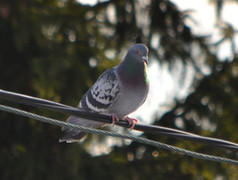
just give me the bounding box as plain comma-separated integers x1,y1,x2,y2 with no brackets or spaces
59,116,104,143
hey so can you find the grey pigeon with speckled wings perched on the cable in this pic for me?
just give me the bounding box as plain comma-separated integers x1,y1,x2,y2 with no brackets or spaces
59,44,149,143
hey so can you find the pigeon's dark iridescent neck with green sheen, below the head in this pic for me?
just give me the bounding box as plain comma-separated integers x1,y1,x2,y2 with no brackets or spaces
117,59,148,85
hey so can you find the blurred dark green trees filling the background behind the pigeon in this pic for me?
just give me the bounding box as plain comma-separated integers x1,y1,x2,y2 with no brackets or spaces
0,0,238,180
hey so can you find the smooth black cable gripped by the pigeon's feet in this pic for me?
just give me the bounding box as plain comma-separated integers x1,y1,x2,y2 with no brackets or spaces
0,89,238,151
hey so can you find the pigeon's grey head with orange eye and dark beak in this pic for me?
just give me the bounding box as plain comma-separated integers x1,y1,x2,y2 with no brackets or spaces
127,44,148,65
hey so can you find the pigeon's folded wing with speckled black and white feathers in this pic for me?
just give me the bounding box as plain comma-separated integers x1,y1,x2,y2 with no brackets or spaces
79,68,121,112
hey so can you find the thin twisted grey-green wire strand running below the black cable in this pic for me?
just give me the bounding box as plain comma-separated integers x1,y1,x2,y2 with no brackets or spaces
0,105,238,166
